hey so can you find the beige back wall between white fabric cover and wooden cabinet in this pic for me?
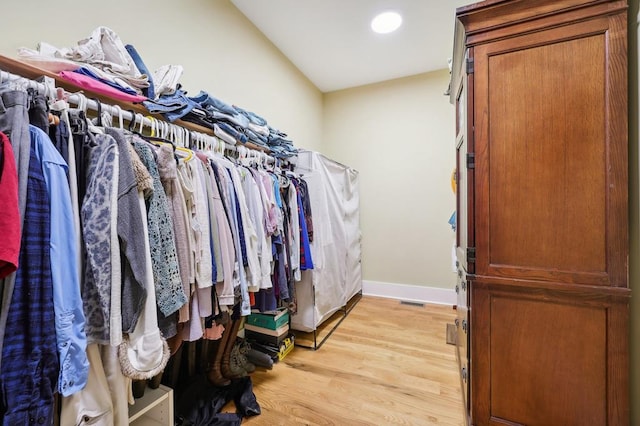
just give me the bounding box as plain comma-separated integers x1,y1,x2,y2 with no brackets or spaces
323,70,455,289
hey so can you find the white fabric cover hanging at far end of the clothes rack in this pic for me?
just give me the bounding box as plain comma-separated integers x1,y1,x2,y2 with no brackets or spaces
291,150,362,332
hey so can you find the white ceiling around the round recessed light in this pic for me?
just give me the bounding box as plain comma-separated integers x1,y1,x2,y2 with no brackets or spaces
231,0,473,92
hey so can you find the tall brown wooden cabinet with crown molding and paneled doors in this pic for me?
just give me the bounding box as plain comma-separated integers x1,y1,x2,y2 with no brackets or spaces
451,0,630,425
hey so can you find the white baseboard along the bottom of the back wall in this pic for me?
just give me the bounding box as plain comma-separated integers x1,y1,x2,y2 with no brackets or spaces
362,280,457,306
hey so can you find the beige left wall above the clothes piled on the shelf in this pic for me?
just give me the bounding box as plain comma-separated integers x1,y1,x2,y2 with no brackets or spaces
0,0,322,150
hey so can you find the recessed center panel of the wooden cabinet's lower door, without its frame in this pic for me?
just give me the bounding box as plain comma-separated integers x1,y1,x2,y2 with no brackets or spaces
490,297,607,425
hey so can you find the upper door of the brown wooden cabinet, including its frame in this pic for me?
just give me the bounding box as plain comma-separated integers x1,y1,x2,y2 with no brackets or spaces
474,14,628,287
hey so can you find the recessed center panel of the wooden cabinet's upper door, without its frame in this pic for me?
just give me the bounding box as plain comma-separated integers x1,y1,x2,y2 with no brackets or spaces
488,36,606,273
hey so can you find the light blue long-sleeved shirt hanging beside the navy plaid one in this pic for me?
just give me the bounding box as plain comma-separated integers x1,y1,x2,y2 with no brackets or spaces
29,126,89,396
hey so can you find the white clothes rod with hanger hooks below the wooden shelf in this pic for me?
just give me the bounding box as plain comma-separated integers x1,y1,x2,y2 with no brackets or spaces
0,70,277,163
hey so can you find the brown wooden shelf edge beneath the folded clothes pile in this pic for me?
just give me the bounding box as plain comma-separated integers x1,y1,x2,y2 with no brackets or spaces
0,55,271,154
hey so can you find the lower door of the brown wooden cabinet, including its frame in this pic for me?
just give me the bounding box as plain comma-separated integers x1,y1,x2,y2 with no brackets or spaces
471,280,629,425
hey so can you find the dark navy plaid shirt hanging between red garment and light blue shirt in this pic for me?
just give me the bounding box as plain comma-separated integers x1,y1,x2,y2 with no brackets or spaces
0,128,59,425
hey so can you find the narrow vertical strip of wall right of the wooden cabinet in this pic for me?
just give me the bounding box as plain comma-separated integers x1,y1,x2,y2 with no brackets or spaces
629,0,640,425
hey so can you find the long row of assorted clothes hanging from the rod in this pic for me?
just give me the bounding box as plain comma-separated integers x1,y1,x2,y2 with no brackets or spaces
0,61,322,425
